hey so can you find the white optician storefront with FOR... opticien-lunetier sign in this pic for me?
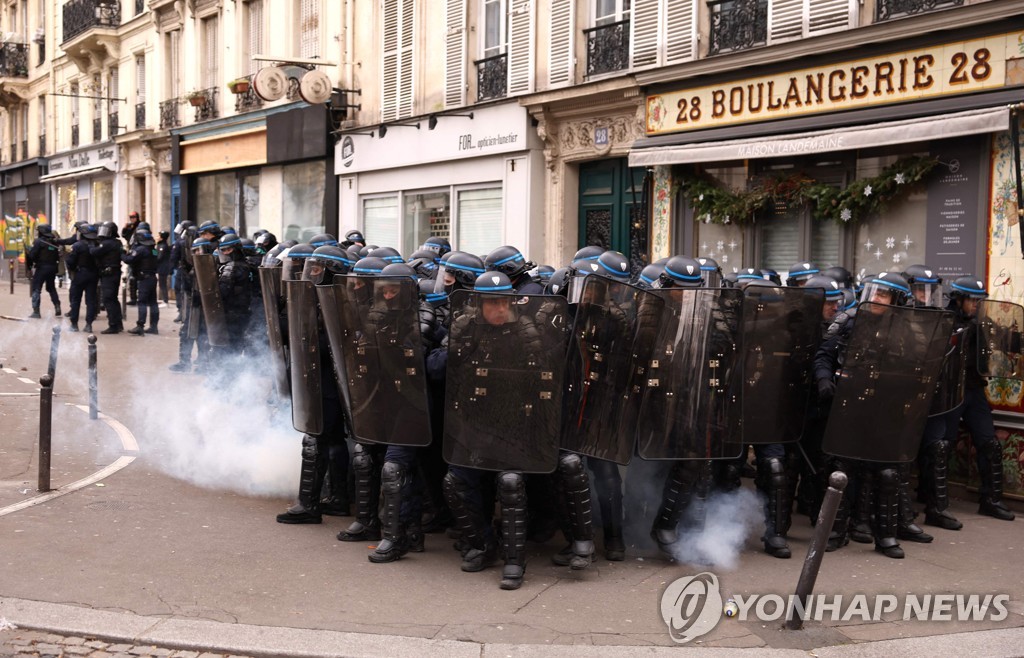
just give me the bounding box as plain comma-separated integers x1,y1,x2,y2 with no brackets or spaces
335,103,545,257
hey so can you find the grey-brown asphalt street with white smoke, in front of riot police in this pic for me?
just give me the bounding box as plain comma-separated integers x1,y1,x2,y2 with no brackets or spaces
0,276,1024,657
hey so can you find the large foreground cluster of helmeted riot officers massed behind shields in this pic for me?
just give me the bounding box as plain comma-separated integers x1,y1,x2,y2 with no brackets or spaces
157,221,1014,589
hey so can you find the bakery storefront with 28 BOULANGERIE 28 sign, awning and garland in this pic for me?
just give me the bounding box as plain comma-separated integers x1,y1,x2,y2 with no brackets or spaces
630,24,1024,493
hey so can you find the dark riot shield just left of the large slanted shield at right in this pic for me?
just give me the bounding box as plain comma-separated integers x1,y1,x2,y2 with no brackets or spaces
739,286,824,445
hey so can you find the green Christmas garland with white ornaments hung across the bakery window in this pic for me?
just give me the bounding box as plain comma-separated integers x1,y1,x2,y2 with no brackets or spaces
679,156,939,225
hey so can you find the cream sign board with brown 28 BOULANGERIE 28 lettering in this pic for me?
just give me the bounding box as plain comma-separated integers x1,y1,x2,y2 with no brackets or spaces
647,32,1024,135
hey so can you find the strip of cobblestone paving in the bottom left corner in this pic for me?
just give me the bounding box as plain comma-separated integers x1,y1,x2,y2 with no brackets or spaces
0,628,250,658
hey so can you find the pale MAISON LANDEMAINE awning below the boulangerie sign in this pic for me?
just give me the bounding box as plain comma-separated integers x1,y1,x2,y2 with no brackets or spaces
630,107,1010,167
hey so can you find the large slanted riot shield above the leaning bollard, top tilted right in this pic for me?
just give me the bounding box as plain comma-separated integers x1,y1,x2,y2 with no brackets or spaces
822,303,953,463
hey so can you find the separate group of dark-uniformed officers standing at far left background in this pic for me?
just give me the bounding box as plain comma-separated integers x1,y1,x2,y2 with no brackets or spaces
26,212,172,336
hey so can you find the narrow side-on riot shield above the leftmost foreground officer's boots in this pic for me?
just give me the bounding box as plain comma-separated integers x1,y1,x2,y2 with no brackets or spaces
284,280,321,434
